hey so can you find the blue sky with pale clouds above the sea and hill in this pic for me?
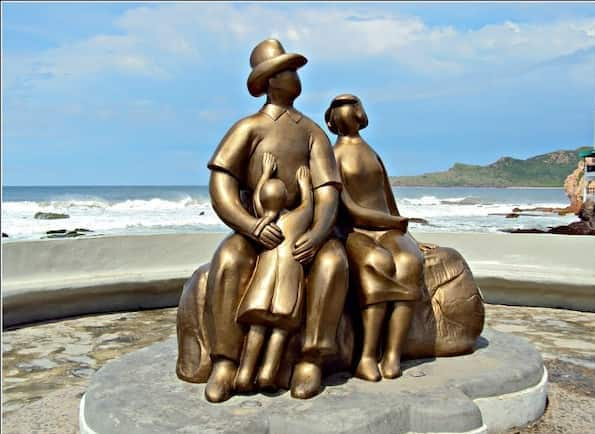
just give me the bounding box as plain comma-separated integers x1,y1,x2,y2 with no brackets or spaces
2,2,595,185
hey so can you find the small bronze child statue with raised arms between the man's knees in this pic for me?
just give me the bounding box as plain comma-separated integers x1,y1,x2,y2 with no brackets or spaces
235,152,314,392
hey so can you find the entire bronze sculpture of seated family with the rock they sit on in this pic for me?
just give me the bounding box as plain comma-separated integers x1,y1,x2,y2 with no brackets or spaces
176,39,483,402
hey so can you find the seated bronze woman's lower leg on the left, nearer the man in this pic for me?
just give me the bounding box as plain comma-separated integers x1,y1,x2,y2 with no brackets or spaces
355,303,386,381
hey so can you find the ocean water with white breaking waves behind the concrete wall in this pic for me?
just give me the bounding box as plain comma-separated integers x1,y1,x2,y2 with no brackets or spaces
1,186,576,240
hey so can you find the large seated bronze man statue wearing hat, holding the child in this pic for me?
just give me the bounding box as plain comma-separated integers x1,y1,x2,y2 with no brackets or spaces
205,39,348,402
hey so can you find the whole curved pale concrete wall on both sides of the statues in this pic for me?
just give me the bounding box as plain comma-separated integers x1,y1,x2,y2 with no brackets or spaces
2,232,595,327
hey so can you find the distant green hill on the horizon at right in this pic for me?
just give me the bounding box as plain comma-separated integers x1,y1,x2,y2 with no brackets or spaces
390,147,590,187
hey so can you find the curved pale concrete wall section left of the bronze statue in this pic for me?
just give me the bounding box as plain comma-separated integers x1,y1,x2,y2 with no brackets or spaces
2,233,225,327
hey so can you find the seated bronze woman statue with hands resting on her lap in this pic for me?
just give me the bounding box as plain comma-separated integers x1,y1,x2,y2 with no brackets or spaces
325,95,423,381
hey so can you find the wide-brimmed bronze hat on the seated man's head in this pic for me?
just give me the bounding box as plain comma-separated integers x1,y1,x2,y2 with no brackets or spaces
248,39,308,96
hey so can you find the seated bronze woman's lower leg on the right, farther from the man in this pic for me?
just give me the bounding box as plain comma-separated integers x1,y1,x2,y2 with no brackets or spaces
380,301,414,378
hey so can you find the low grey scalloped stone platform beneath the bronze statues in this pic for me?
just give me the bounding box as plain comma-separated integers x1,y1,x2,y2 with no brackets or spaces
80,329,547,434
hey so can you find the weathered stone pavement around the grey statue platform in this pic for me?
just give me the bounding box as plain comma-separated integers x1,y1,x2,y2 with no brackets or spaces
2,305,595,434
